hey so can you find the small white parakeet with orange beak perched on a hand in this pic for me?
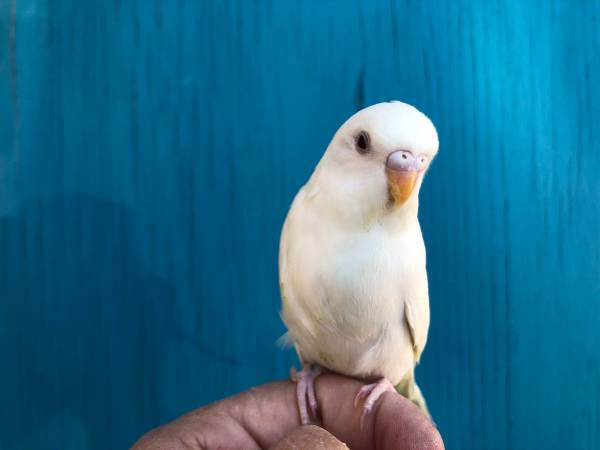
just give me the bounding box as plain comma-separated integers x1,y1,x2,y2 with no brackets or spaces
279,101,438,423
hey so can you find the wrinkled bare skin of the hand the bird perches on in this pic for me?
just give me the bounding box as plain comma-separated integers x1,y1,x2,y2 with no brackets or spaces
133,374,444,450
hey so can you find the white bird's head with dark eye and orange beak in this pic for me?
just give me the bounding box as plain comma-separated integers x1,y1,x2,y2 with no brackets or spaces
309,101,438,225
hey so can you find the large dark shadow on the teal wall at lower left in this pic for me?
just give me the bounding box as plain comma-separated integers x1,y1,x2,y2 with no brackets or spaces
0,196,174,449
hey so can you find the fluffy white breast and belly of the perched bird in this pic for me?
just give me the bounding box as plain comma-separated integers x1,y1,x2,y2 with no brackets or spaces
281,193,425,382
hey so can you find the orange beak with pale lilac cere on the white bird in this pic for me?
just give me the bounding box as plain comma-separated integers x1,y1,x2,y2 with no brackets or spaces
385,150,420,206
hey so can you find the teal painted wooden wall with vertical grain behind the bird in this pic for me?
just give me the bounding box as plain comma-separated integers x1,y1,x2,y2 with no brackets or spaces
0,0,600,450
